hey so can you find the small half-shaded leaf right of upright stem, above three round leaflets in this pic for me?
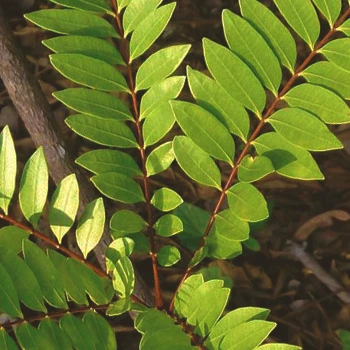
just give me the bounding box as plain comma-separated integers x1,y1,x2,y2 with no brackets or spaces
146,141,175,176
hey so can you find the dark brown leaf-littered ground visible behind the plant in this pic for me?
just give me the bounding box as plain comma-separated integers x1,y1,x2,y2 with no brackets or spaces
0,0,350,350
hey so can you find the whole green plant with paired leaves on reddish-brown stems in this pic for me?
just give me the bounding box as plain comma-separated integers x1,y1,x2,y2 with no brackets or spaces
0,0,350,350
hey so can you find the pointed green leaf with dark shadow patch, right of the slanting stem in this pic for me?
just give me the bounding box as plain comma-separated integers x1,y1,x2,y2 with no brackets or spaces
253,132,324,180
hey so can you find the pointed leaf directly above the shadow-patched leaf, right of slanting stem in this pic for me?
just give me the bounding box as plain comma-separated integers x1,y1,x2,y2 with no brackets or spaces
268,108,343,151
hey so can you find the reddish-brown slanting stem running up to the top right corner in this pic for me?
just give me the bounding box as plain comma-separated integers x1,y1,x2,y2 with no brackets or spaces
169,8,350,312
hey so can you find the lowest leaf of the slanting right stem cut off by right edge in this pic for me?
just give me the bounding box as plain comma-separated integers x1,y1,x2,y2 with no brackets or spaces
283,83,350,124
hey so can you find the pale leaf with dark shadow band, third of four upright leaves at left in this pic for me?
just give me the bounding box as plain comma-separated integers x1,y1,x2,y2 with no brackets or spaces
49,174,79,243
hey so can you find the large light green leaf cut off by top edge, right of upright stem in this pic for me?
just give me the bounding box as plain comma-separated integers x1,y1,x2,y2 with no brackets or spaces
123,0,162,38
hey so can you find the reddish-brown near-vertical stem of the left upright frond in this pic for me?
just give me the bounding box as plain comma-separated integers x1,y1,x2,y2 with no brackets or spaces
112,0,163,309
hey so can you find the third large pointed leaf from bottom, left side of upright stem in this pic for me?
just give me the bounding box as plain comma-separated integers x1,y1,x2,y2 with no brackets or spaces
66,114,137,148
